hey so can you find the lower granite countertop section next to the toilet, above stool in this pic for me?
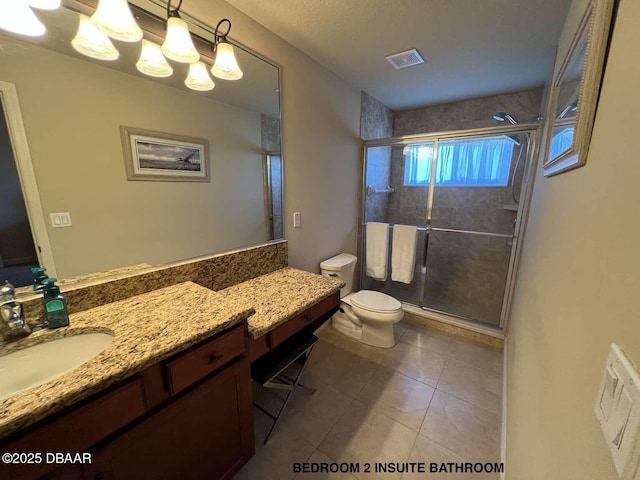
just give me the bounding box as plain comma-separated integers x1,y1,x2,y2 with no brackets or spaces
218,267,344,338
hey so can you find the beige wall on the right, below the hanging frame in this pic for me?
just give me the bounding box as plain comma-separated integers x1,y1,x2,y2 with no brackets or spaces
506,0,640,480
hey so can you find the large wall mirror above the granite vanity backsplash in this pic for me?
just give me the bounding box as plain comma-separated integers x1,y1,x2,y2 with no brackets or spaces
0,0,283,285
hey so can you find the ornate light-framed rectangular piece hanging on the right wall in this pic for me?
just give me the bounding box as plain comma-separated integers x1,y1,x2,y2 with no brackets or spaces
542,0,614,177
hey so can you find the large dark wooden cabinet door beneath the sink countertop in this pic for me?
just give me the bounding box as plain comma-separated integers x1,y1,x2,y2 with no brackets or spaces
89,359,254,480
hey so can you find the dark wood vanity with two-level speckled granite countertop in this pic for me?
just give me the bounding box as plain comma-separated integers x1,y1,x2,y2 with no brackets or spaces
0,268,341,480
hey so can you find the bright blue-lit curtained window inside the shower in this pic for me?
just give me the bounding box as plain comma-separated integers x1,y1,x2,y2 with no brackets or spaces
403,135,517,186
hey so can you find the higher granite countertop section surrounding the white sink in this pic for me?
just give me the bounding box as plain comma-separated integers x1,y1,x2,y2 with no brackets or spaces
0,282,255,439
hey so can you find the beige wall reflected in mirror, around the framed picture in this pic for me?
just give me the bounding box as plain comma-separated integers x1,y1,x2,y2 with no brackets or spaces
0,41,266,278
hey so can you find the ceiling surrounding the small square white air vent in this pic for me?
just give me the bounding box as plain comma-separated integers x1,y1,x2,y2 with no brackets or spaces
227,0,571,110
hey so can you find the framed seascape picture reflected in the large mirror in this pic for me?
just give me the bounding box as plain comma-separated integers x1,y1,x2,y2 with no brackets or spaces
120,127,210,182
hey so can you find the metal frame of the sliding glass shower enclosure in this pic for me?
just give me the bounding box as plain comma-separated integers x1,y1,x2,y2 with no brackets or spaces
358,123,542,337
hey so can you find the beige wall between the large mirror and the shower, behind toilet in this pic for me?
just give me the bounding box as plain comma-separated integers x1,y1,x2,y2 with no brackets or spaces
183,0,360,271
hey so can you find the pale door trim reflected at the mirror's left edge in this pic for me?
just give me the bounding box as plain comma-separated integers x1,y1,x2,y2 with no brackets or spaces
0,81,57,277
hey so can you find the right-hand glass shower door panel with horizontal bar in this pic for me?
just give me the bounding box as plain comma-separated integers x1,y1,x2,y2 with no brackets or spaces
421,134,528,326
